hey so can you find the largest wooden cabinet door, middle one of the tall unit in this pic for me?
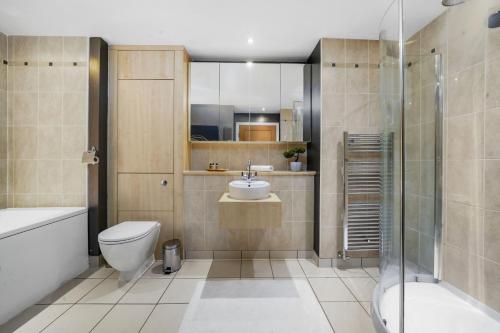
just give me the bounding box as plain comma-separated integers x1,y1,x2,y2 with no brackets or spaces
117,80,174,173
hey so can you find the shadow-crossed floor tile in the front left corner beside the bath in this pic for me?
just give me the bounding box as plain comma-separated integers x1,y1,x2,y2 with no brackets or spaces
0,304,71,333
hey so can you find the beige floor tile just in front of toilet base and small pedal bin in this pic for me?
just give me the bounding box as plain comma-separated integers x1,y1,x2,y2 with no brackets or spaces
120,279,172,304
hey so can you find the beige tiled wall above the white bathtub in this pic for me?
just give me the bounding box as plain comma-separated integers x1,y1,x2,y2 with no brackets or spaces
5,36,88,207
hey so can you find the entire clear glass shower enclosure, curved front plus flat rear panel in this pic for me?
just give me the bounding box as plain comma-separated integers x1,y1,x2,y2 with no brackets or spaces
373,0,443,333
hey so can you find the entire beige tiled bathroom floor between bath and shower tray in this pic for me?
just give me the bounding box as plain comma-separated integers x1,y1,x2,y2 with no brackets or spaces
0,259,378,333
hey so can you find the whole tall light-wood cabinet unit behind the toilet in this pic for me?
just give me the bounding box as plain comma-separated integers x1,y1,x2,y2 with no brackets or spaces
108,46,188,258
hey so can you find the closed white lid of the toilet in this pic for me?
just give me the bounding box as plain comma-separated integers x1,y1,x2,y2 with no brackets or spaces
98,221,158,242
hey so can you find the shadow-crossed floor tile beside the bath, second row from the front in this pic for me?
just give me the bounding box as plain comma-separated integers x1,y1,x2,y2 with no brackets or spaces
38,279,103,304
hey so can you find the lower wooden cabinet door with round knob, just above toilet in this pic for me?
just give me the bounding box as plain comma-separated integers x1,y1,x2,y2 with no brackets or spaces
118,173,174,211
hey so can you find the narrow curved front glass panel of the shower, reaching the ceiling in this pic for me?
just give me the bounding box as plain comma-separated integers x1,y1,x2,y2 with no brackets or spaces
372,0,404,332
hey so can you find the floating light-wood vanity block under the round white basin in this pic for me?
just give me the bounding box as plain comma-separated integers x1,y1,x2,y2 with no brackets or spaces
219,193,281,229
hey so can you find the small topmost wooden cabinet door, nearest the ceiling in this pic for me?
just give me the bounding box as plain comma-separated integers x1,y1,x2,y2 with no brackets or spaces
118,51,175,80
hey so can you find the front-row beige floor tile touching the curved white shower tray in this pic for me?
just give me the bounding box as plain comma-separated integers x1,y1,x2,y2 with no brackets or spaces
321,302,375,333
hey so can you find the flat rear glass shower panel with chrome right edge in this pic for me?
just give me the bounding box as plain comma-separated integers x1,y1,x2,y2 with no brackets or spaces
403,50,443,282
